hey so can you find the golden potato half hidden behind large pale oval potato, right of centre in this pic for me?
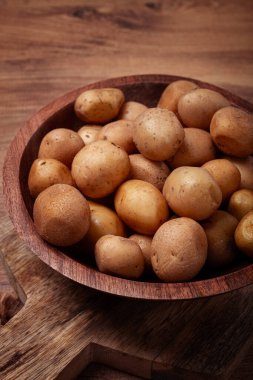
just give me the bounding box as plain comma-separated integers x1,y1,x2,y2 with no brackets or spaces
202,158,241,201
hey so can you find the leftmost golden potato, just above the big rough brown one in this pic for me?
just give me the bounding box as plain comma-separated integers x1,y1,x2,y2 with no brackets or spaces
28,158,75,198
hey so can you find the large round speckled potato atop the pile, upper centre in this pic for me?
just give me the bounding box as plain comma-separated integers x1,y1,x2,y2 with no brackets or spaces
133,108,184,161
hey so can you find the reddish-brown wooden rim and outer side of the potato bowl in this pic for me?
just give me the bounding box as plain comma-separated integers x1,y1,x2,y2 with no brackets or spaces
3,74,253,300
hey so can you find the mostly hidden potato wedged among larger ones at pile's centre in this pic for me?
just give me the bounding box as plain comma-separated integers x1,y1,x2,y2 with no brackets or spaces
129,154,170,191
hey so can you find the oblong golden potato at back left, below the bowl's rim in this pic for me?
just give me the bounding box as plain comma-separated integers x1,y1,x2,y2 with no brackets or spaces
74,88,125,124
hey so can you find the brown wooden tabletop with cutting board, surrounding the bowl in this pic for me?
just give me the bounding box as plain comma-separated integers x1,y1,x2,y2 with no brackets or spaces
0,0,253,380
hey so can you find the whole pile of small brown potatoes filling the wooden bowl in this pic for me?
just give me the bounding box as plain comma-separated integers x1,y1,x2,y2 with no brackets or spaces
28,80,253,282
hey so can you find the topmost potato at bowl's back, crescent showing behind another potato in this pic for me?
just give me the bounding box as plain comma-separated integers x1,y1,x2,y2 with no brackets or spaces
157,80,199,113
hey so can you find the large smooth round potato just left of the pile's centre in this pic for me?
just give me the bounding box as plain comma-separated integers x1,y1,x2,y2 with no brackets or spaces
72,140,130,198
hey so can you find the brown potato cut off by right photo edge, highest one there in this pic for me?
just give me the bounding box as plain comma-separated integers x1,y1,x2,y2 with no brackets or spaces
210,106,253,157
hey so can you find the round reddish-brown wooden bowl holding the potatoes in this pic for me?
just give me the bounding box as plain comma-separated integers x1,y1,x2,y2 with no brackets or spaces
4,75,253,300
